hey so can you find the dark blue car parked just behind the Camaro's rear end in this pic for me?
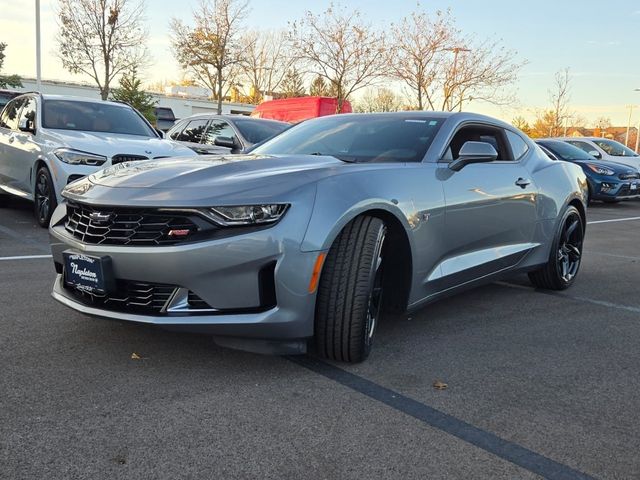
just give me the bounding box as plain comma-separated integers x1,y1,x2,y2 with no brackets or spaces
536,139,640,203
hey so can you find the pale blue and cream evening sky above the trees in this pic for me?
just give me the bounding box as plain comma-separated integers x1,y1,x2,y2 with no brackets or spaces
0,0,640,125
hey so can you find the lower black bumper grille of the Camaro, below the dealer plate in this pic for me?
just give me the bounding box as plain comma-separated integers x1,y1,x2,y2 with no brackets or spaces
66,280,178,314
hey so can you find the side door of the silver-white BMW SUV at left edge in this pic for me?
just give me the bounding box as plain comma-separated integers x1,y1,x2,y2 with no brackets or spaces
0,97,26,195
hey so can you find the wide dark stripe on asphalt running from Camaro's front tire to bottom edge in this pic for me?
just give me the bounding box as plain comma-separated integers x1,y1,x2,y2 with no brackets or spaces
287,356,594,480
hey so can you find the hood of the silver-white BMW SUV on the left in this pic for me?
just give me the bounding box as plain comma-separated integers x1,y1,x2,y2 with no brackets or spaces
47,129,195,158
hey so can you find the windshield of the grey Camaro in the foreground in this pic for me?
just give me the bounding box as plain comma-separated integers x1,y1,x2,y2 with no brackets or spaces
252,114,444,162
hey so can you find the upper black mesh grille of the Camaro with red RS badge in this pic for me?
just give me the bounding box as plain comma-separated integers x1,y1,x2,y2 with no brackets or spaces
65,203,200,246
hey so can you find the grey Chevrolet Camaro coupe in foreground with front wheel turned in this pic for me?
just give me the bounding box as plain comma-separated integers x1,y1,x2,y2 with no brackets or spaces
50,112,587,362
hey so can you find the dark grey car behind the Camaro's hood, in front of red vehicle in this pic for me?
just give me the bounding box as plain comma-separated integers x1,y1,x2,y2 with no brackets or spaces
167,113,291,155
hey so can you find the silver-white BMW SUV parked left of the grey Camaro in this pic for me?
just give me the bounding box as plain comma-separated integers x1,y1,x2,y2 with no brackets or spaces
0,93,194,227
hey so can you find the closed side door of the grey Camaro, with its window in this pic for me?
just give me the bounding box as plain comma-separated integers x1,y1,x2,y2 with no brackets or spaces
433,123,537,288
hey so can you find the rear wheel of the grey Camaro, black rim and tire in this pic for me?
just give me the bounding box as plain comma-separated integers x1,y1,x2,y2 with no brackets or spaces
529,205,584,290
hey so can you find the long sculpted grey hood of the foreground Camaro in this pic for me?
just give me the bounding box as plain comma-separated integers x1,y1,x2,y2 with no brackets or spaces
63,155,352,206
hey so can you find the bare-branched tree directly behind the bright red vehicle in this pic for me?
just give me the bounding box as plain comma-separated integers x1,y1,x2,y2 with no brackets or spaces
290,5,388,112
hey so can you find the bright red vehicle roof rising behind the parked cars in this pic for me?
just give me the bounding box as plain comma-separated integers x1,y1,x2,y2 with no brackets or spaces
251,97,351,123
